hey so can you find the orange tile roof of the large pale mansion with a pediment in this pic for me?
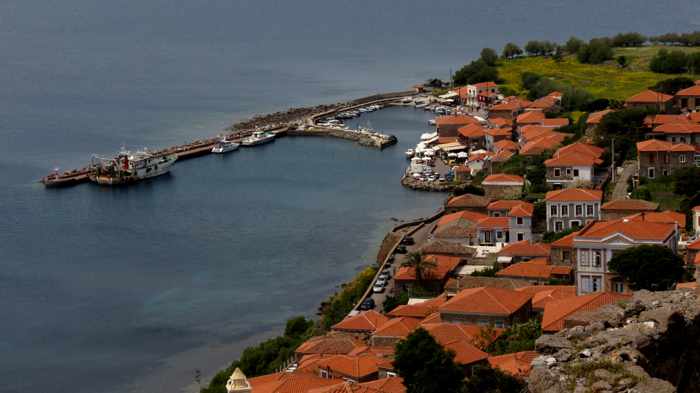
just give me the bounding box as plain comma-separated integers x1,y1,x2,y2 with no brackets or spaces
574,218,676,243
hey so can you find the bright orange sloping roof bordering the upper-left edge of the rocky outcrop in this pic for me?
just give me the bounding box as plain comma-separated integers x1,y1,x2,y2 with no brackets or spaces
542,292,631,333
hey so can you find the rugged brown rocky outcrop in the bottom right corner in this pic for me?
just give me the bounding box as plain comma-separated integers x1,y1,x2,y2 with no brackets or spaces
528,290,700,393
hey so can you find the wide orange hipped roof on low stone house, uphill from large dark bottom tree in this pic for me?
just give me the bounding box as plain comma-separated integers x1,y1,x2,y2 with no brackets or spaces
439,287,531,316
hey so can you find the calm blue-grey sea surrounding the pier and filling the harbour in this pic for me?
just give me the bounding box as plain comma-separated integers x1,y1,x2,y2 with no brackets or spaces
0,0,700,393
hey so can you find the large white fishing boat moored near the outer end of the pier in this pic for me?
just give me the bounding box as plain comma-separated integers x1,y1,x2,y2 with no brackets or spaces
88,149,177,186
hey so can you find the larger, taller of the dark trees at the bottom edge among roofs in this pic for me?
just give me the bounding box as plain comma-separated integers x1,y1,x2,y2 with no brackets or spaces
394,328,464,393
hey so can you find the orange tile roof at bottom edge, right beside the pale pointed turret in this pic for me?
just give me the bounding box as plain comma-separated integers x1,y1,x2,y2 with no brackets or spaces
248,372,342,393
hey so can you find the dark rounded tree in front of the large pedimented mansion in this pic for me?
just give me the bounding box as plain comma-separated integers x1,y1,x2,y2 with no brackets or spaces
609,245,685,291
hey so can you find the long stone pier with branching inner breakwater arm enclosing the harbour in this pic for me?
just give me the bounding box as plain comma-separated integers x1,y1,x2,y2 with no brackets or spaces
41,91,416,187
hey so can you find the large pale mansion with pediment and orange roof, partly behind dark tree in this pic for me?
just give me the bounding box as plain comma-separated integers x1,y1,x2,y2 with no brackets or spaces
574,216,680,295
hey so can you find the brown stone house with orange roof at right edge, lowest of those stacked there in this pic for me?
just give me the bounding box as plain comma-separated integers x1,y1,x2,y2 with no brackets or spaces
637,139,695,179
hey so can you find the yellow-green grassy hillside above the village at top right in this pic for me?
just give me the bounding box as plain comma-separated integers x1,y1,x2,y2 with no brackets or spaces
498,46,700,100
